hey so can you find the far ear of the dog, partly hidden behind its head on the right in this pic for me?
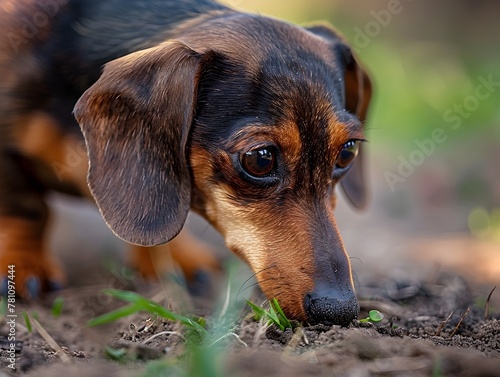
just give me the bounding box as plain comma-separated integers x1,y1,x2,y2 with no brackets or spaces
308,25,372,209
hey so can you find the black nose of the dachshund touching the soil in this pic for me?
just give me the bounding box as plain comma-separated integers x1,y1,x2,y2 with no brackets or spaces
304,290,359,326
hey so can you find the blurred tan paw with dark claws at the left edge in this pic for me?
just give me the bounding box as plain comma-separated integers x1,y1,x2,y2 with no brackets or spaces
0,250,64,300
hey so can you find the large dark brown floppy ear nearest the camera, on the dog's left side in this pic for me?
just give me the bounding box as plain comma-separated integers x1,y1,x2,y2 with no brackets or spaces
74,42,202,246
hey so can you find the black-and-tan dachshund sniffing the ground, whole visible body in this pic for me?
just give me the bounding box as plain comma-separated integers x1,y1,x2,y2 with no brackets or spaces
0,0,372,326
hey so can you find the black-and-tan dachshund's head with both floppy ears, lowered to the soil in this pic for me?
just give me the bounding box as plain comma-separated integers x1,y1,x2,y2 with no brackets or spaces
75,15,371,325
